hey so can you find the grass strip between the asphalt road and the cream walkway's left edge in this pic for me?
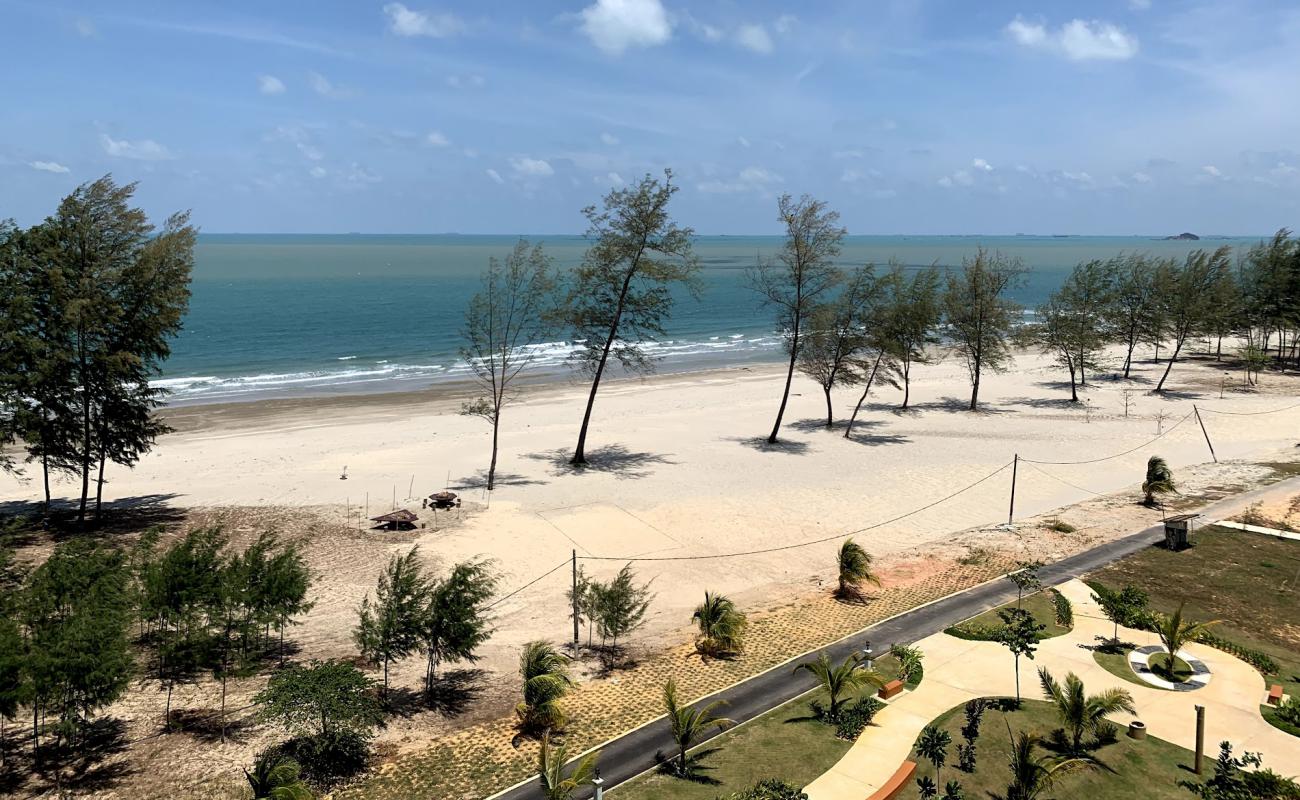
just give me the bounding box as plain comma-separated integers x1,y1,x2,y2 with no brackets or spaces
610,656,920,800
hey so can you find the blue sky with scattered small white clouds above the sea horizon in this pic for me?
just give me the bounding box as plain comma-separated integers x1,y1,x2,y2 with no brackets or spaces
0,0,1300,234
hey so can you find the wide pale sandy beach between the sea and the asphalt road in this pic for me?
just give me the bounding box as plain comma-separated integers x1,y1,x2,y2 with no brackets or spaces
0,343,1300,796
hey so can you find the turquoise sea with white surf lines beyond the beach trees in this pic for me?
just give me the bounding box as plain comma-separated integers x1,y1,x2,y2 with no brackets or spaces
165,234,1261,405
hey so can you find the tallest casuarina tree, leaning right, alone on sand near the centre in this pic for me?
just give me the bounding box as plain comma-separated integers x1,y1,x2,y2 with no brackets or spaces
562,170,698,466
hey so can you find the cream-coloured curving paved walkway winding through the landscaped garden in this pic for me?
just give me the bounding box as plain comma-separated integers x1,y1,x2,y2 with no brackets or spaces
805,580,1300,800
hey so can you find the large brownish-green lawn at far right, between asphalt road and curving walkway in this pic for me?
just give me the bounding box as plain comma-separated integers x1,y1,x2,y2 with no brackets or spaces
1088,527,1300,735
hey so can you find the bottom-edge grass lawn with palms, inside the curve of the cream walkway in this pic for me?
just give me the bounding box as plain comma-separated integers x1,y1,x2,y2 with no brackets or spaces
898,700,1196,800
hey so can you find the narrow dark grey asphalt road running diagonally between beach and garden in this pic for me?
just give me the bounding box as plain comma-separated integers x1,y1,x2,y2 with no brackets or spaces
493,481,1291,800
